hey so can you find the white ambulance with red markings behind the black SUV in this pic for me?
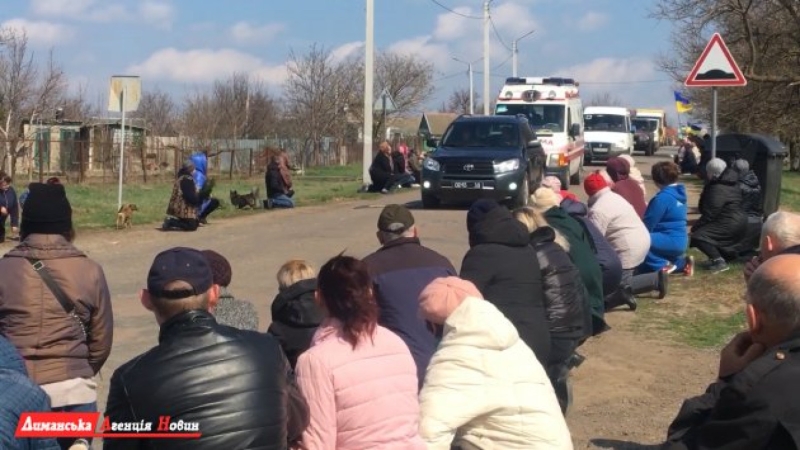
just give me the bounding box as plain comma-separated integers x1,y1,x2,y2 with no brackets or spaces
495,77,584,186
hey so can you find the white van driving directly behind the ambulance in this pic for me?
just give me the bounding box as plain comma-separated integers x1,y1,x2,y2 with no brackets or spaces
583,106,633,163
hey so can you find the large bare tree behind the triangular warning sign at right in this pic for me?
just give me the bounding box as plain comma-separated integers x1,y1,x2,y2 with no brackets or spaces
651,0,800,169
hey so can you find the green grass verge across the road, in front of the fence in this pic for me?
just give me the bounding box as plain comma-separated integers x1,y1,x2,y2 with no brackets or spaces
67,164,377,231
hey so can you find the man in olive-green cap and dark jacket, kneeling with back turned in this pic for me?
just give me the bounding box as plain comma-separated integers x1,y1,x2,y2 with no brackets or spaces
364,205,457,387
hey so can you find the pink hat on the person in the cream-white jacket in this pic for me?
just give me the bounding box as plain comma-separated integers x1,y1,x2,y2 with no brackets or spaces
419,277,483,325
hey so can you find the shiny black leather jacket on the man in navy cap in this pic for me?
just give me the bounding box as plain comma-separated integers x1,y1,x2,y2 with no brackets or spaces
103,310,302,450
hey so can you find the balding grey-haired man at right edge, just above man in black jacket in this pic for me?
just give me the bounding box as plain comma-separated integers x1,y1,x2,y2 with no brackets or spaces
744,211,800,281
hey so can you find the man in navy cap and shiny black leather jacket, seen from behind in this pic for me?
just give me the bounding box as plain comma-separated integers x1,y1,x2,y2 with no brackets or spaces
104,247,308,450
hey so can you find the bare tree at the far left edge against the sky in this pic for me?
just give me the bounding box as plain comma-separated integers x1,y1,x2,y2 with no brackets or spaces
0,30,66,174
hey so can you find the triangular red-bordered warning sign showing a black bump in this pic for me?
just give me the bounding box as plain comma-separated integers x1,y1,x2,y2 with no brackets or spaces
684,33,747,87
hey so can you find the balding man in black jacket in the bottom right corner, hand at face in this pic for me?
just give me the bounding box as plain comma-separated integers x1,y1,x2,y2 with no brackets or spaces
663,255,800,450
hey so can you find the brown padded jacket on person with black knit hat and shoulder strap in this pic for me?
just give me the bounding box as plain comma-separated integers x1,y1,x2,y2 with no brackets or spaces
0,234,114,385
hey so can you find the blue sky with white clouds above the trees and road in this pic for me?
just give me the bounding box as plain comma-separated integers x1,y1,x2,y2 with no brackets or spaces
0,0,675,123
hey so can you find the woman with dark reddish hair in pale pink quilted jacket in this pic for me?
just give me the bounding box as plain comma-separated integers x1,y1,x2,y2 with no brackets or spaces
296,255,425,450
